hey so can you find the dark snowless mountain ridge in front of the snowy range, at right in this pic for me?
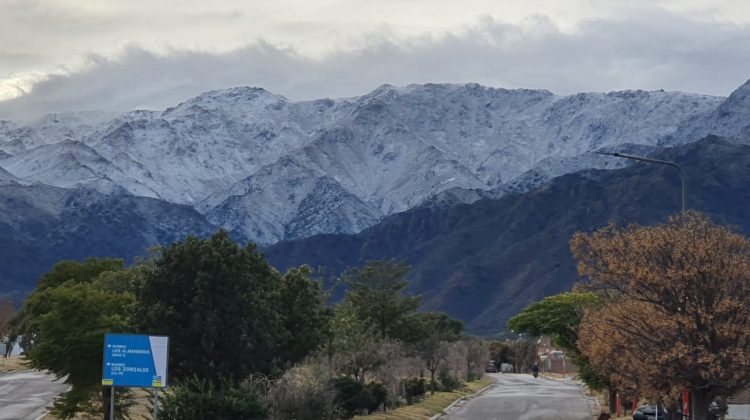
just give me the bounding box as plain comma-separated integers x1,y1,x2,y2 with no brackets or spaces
265,137,750,335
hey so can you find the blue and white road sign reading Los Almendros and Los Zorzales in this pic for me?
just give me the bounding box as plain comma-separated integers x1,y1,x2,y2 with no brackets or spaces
102,334,169,388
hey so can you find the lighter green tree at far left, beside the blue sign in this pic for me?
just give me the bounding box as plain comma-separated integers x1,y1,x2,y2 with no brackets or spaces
16,259,134,418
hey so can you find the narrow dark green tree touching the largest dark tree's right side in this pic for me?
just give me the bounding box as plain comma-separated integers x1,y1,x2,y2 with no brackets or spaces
275,266,332,364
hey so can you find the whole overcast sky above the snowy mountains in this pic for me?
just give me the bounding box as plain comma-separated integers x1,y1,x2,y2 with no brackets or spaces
0,0,750,119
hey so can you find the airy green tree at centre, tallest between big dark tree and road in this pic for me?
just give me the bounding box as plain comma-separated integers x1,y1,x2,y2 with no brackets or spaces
341,260,420,339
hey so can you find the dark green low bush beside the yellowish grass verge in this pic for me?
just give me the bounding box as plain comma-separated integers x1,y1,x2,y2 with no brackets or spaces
333,376,388,419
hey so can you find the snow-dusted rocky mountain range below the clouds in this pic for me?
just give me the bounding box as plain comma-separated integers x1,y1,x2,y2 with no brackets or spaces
0,84,750,243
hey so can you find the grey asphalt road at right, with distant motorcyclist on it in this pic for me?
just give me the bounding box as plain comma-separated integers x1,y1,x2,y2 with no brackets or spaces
441,374,593,420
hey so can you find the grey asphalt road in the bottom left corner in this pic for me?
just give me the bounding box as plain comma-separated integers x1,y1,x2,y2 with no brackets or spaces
0,370,68,420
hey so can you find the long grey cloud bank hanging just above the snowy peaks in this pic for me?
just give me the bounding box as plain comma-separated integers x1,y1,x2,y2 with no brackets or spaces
0,11,750,119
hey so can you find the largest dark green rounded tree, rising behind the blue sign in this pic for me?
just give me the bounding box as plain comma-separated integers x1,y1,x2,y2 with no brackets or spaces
134,231,284,385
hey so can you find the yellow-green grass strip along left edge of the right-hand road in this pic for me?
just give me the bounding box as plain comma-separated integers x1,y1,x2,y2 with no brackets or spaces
355,378,491,420
